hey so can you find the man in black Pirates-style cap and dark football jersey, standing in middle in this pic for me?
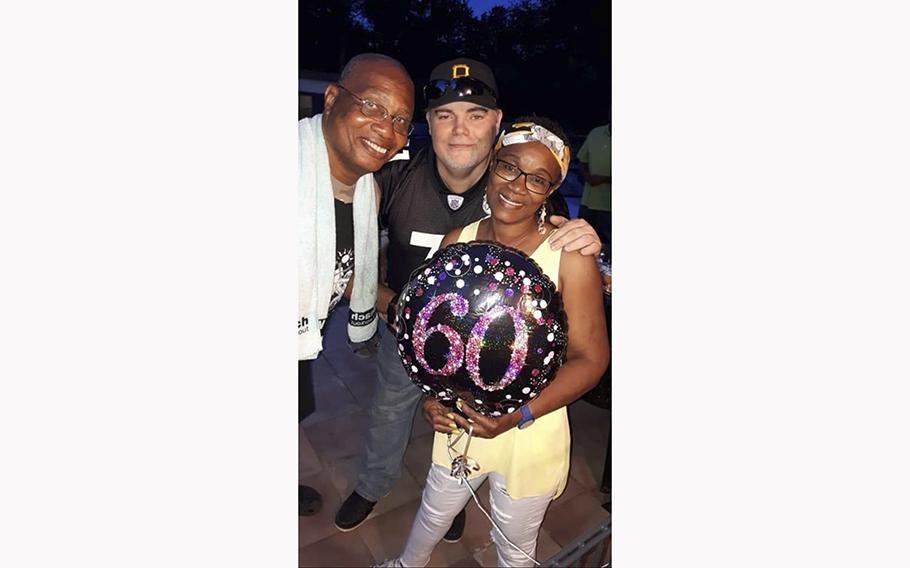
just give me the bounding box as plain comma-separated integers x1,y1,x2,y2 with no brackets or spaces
335,58,601,542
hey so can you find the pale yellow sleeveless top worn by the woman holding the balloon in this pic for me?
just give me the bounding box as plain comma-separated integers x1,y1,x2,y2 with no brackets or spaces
433,221,571,499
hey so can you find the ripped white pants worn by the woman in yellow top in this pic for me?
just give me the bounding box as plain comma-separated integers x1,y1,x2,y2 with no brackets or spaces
397,464,554,568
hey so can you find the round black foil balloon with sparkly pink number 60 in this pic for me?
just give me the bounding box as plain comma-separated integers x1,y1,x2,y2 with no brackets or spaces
395,242,568,416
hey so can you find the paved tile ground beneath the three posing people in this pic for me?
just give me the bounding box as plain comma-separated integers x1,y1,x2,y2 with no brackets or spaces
299,307,610,567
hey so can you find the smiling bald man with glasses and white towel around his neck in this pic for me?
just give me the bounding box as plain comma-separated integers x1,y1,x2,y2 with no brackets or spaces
298,54,414,515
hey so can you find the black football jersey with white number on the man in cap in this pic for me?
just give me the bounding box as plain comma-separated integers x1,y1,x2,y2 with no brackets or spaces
374,146,489,292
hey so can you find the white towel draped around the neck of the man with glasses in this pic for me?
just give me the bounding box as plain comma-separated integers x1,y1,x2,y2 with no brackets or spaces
297,115,379,359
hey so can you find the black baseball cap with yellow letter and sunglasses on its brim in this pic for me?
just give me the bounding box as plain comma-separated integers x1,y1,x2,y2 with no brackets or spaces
423,57,499,110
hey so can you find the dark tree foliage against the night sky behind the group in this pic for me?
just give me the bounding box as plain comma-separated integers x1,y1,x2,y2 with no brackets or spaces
300,0,610,135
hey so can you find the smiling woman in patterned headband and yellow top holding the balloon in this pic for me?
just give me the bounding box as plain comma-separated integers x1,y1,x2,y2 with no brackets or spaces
383,117,609,567
